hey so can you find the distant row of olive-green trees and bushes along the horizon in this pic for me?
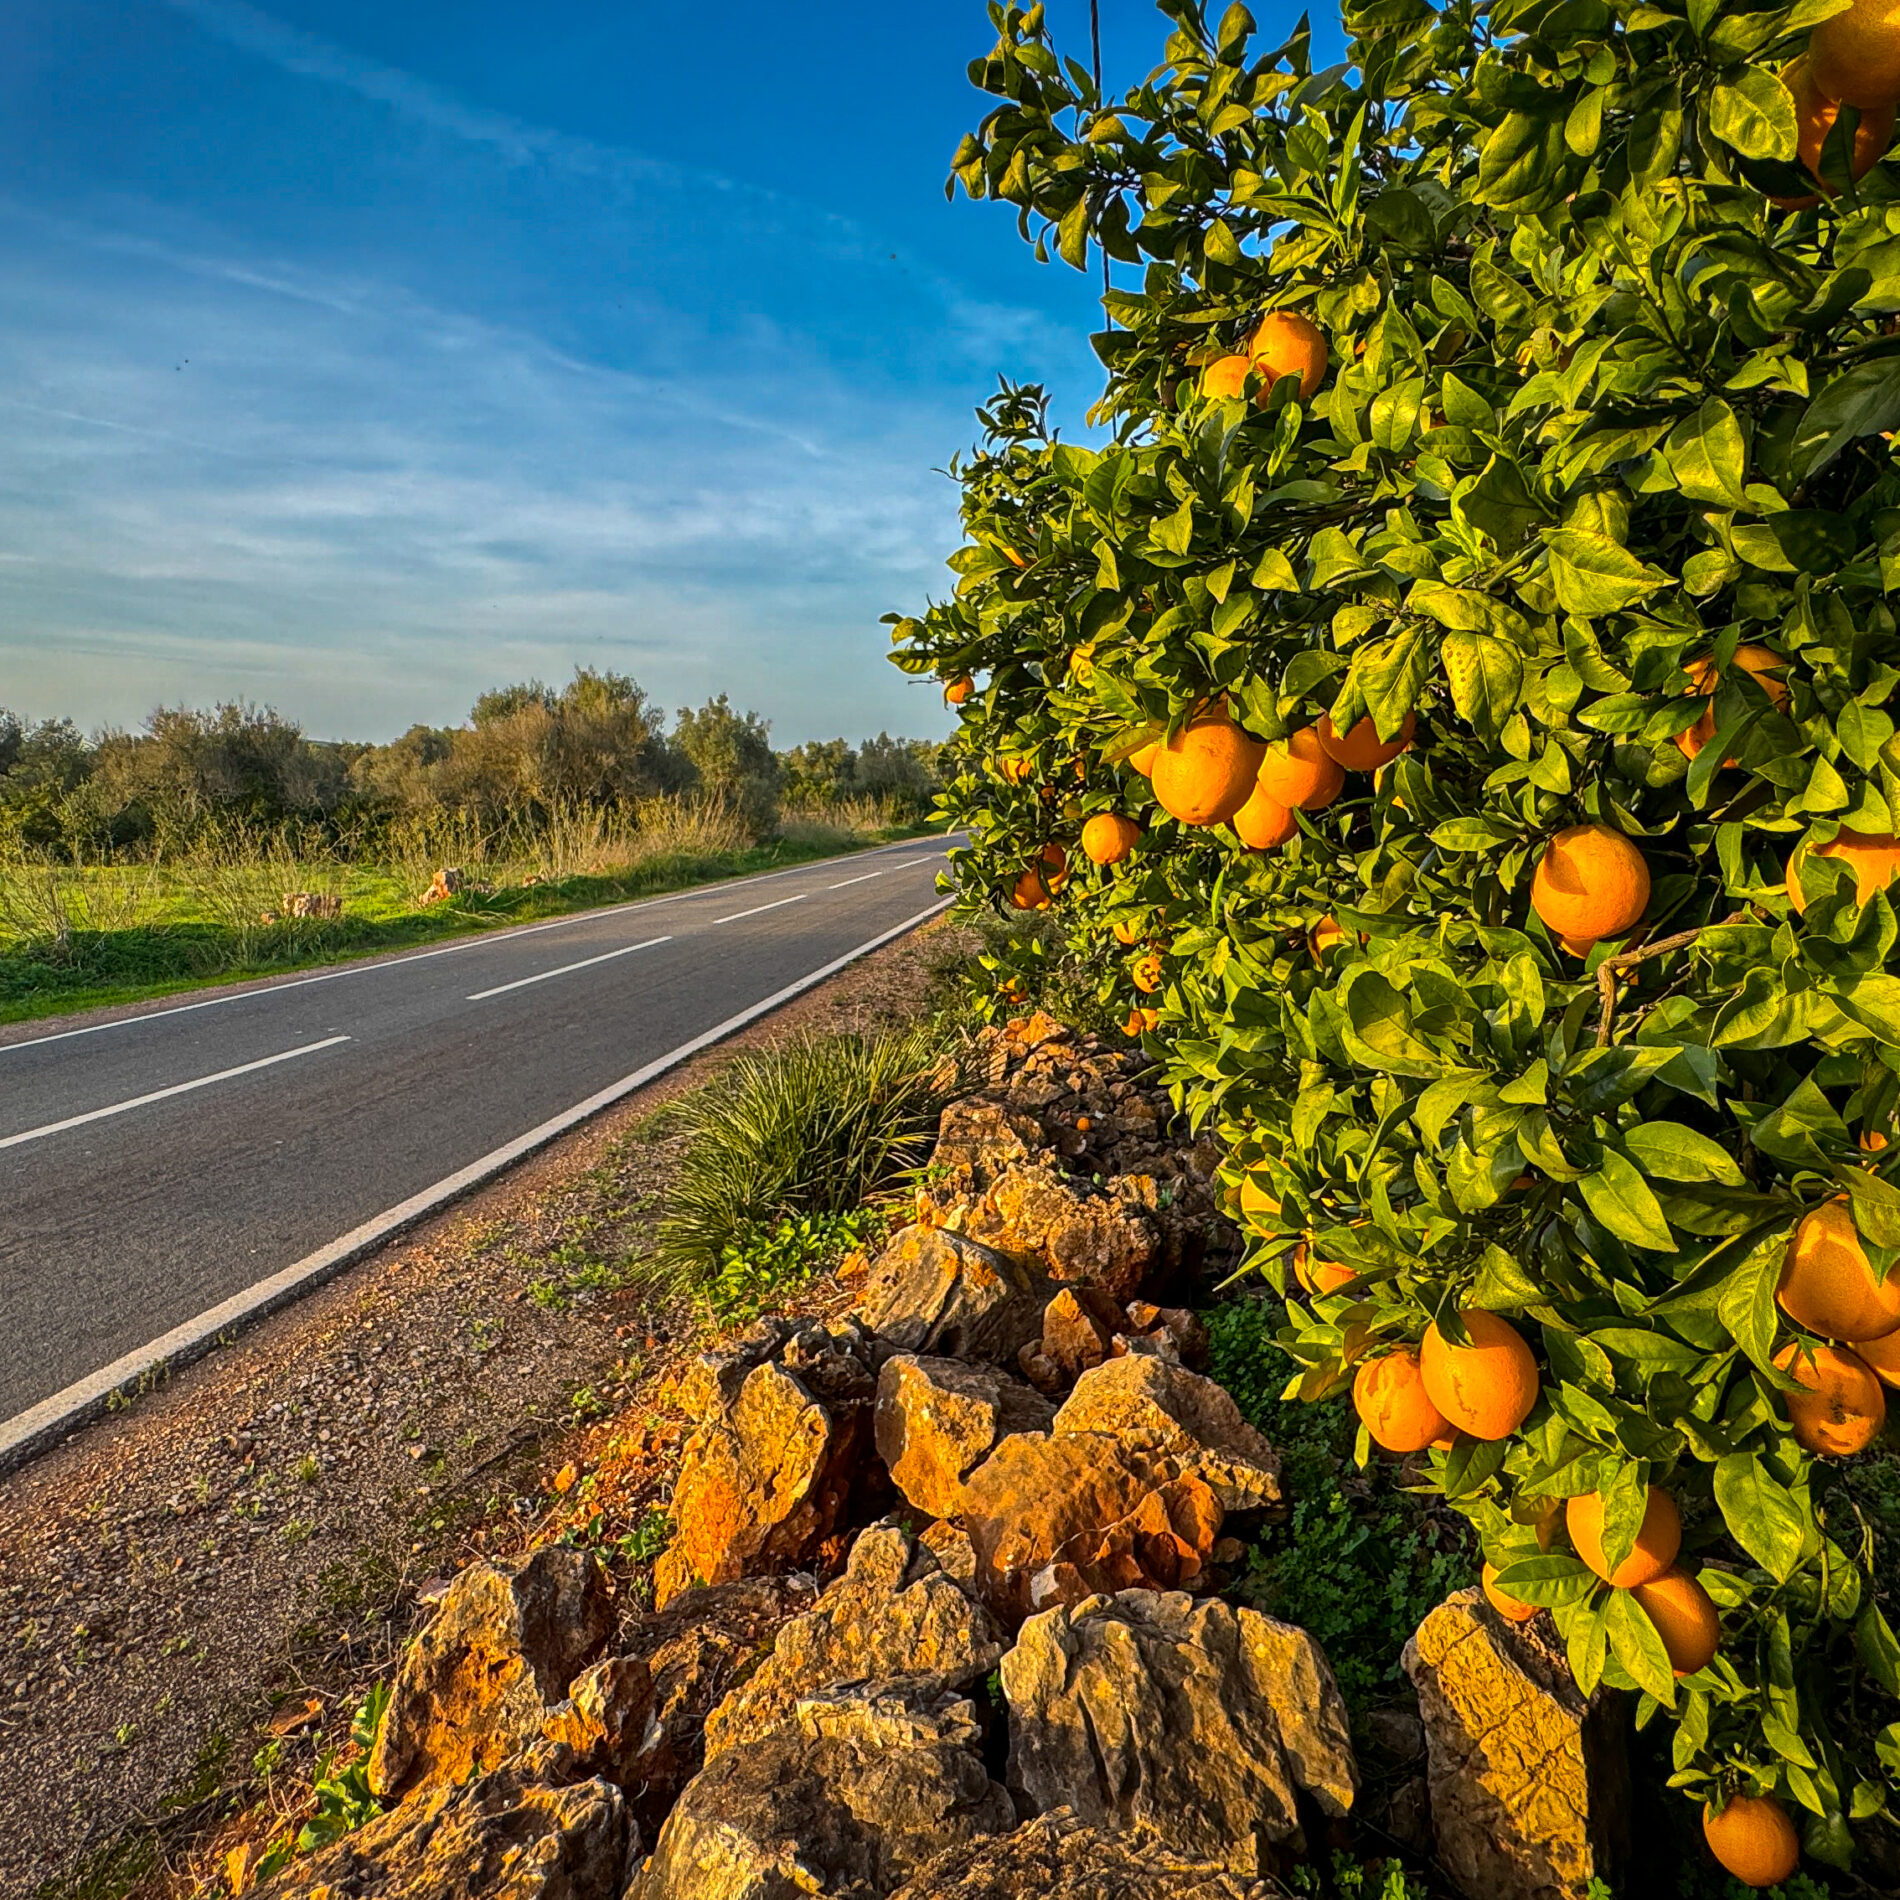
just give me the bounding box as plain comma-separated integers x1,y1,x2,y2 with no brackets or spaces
0,667,939,855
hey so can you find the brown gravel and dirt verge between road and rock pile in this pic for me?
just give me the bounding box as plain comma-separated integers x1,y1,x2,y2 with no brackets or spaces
0,923,965,1900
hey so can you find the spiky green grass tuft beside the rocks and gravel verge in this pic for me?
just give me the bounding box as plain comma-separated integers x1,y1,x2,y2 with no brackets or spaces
659,1028,961,1284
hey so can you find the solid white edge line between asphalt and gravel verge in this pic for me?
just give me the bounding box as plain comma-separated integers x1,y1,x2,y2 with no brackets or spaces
0,897,950,1473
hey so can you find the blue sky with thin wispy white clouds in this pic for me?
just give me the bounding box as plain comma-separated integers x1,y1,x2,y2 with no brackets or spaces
0,0,1246,745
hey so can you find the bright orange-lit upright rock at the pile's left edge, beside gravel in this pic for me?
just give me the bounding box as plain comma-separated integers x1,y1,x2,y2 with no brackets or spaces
654,1360,874,1607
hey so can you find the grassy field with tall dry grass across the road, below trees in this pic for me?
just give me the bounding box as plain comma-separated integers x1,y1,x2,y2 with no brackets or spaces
0,800,916,1022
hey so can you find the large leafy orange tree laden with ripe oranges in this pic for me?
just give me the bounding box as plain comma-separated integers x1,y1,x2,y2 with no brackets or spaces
891,0,1900,1864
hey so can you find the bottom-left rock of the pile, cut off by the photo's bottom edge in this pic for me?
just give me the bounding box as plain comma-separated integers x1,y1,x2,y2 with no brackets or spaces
258,1765,637,1900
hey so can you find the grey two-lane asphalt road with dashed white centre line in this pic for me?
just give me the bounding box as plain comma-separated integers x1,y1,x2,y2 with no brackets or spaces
0,838,946,1436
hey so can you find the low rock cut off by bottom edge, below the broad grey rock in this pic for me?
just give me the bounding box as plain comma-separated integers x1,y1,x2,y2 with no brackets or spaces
891,1807,1269,1900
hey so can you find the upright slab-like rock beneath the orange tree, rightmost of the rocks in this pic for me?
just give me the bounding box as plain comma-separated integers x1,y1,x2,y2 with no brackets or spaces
1402,1590,1630,1900
